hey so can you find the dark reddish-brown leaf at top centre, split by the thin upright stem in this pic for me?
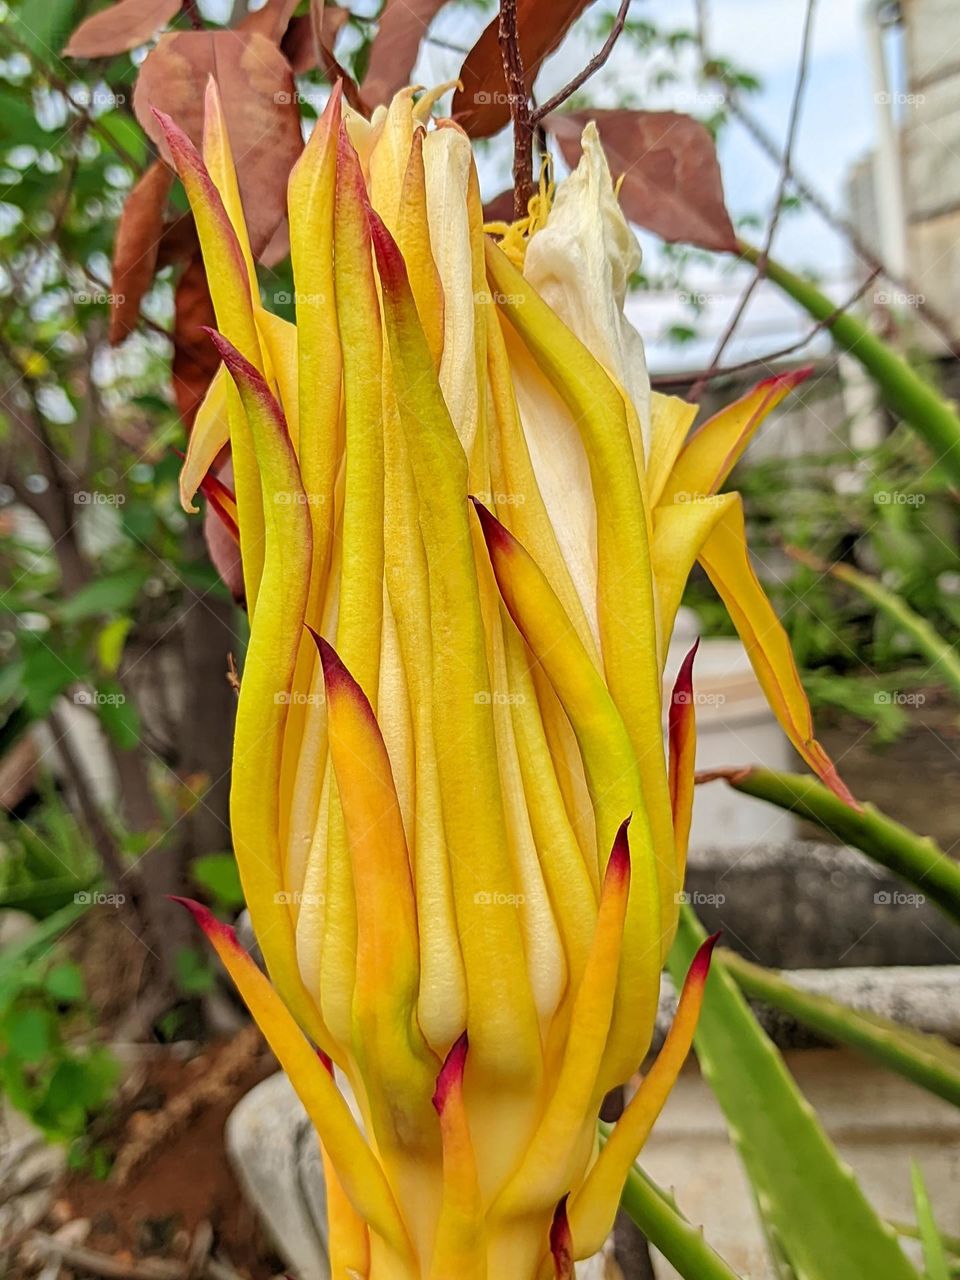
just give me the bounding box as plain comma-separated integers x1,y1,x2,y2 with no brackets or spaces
452,0,590,138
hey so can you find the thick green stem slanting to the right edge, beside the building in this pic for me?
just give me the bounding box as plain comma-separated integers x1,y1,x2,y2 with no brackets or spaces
739,241,960,484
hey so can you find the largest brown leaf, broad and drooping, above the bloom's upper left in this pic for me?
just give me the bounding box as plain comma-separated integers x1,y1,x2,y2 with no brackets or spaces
133,31,303,255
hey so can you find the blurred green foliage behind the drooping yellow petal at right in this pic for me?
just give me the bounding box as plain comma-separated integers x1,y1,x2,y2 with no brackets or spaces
686,425,960,741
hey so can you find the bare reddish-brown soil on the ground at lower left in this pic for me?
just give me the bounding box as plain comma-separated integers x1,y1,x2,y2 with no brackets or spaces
25,1032,283,1280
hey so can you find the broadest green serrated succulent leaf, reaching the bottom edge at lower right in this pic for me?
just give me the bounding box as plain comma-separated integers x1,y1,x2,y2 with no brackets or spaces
668,906,918,1280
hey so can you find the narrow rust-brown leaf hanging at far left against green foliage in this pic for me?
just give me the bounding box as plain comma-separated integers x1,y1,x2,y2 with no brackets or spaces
110,160,173,346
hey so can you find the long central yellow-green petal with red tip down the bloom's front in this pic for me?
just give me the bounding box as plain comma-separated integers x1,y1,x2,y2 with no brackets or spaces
371,204,540,1082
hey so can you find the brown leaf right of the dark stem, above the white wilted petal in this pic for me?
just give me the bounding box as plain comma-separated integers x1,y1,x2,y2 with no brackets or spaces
544,109,737,252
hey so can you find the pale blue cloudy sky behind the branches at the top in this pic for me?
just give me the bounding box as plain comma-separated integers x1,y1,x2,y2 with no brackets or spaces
229,0,896,371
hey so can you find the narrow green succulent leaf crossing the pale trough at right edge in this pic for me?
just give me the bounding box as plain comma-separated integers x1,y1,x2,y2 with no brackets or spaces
714,950,960,1106
